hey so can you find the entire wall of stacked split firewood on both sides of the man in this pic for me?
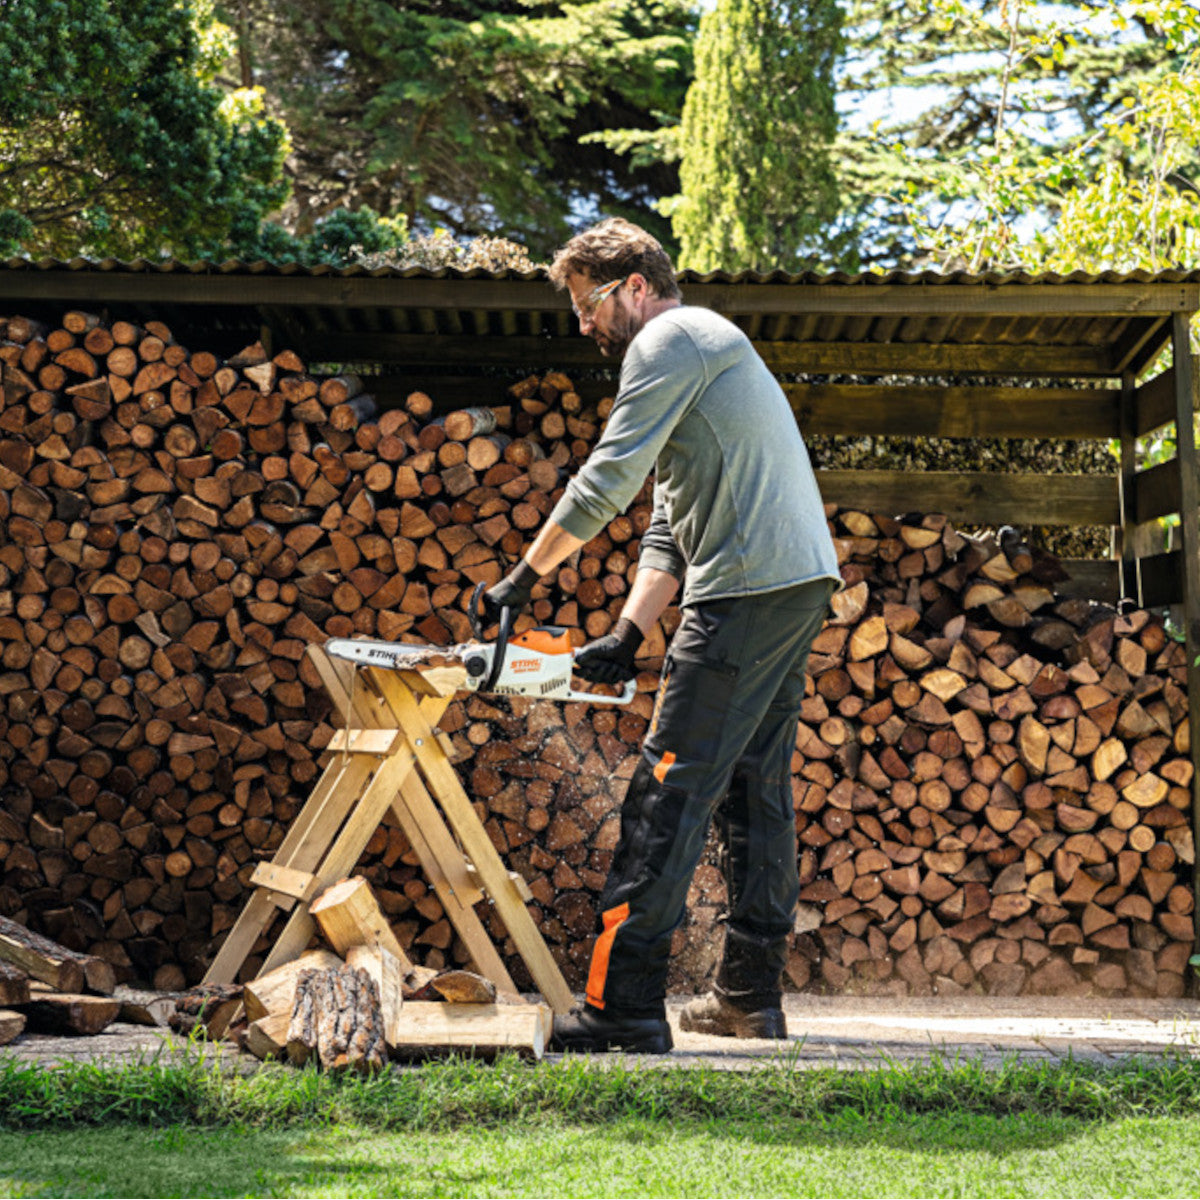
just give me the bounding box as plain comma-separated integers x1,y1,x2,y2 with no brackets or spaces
0,313,1193,994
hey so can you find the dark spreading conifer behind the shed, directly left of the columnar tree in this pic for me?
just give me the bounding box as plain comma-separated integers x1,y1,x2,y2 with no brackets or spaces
220,0,695,253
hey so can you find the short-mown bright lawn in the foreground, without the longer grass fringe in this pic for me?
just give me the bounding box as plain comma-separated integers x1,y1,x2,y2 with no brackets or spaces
0,1115,1200,1196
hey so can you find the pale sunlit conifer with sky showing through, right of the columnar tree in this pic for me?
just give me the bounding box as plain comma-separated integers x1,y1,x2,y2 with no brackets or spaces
838,0,1200,265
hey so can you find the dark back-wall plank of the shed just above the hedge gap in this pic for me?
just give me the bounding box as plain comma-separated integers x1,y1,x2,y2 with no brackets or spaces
782,383,1121,438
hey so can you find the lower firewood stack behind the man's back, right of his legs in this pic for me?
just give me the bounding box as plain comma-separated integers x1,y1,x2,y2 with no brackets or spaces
792,511,1194,995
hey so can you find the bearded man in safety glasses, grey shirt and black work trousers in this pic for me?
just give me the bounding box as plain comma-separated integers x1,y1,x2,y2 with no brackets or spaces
484,220,840,1054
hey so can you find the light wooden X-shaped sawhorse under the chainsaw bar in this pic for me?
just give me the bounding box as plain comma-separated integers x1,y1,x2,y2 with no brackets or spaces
204,647,574,1013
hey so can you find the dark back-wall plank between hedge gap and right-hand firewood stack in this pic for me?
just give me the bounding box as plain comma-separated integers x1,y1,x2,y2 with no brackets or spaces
816,470,1121,526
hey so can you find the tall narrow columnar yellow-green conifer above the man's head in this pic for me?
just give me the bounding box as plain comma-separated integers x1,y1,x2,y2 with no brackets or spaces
671,0,841,271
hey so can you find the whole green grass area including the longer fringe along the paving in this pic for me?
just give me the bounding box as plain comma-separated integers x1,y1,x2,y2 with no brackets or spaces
7,1056,1200,1196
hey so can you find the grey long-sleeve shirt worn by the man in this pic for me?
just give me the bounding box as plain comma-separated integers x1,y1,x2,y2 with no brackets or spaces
551,306,840,605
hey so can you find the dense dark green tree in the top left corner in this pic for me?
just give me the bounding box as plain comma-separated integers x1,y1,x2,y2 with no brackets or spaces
0,0,287,258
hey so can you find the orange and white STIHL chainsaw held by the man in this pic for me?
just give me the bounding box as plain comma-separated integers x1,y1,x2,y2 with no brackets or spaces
325,583,637,704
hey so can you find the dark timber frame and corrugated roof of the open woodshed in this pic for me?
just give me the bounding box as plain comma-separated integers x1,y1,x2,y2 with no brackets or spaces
0,259,1200,947
